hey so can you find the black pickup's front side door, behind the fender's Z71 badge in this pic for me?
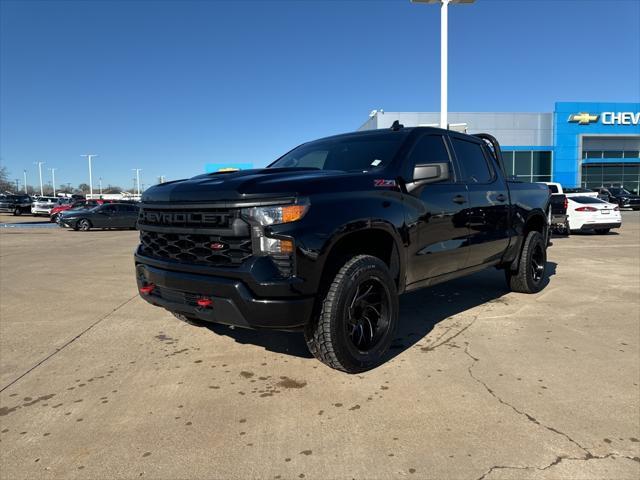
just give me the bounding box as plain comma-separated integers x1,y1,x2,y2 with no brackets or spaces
404,133,469,284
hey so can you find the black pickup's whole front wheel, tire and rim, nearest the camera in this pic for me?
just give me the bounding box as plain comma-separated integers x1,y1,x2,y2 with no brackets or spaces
305,255,398,373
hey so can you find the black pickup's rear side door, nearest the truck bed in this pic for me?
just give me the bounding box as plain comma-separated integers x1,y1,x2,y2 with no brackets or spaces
450,135,510,267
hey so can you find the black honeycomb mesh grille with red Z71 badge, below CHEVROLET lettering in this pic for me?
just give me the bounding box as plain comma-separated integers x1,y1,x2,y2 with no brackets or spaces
140,230,252,267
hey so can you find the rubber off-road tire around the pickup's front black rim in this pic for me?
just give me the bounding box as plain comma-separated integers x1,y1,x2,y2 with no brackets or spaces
304,255,398,373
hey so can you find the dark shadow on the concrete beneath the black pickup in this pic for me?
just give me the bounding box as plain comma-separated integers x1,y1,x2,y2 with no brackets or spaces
206,262,557,361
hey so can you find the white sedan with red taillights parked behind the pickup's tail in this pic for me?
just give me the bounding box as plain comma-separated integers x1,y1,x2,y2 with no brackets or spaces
567,196,622,235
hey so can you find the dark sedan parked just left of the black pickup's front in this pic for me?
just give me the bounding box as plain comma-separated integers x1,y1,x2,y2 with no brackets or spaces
58,203,138,231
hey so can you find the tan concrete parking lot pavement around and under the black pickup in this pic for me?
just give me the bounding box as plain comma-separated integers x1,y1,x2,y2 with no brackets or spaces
0,212,640,479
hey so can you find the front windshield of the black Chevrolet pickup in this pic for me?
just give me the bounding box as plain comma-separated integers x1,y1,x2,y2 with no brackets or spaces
268,132,406,172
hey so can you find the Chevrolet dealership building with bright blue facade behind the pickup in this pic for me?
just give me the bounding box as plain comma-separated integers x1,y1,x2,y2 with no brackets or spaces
360,102,640,193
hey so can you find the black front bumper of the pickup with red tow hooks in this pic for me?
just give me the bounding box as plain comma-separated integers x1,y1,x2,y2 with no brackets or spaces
135,253,314,330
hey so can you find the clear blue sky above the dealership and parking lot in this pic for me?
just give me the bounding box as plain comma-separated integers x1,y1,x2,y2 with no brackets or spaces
0,0,640,188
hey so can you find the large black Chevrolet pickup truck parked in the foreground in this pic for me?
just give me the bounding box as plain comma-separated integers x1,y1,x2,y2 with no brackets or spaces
135,122,549,373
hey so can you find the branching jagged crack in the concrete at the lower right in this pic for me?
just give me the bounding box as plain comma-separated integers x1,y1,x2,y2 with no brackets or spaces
464,344,640,480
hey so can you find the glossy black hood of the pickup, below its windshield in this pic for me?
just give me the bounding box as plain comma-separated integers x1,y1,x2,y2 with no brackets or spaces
142,168,371,202
